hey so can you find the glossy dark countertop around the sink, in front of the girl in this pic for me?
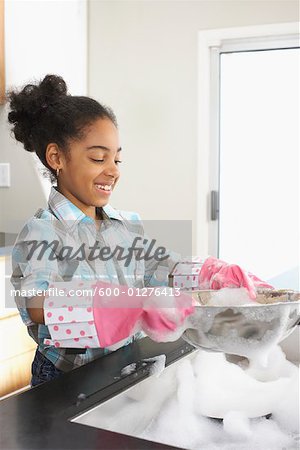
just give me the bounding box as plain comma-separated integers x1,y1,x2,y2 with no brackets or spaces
0,338,194,450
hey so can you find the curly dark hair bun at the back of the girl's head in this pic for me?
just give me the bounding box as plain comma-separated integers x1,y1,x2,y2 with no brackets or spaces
8,75,67,152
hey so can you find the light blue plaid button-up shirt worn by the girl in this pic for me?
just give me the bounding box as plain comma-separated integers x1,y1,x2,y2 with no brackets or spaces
11,186,180,371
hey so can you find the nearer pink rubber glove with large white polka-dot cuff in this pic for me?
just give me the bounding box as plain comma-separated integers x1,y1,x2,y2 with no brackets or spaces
44,281,195,348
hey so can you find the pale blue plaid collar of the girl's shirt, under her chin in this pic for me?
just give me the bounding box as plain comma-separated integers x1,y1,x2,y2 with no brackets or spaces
48,186,123,228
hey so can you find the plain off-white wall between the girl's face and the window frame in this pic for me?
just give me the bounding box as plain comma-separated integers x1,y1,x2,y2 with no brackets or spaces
88,0,299,253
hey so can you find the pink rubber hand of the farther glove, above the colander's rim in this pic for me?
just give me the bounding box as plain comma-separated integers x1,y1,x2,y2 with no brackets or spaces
199,257,273,300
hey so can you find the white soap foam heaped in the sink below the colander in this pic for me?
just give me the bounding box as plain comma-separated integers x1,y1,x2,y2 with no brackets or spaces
139,347,299,450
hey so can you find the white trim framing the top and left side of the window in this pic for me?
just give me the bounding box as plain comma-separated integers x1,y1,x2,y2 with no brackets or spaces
196,22,300,256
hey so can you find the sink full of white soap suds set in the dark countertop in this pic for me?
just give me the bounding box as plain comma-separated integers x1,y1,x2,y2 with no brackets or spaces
77,346,299,450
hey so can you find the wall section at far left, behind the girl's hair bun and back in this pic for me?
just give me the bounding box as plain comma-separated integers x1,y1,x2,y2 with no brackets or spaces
0,0,87,232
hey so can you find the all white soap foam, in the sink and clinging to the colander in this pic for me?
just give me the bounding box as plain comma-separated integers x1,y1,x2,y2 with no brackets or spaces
135,289,299,450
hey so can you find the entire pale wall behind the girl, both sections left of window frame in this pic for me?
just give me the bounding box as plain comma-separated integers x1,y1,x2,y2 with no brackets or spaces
0,0,299,244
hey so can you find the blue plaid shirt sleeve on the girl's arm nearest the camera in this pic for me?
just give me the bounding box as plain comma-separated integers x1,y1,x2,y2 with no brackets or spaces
10,217,64,326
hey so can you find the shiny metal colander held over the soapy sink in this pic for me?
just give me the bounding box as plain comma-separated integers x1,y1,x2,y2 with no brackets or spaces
182,288,300,358
